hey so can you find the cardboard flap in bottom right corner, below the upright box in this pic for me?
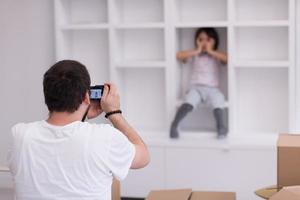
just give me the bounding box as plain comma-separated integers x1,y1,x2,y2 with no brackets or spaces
270,186,300,200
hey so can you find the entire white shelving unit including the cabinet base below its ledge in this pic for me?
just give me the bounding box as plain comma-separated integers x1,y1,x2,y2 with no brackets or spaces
55,0,300,200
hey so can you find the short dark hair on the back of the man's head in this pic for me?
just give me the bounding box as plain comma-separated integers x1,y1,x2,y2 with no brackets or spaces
43,60,91,113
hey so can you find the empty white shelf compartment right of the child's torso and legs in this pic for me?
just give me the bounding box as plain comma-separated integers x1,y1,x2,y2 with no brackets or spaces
235,68,289,134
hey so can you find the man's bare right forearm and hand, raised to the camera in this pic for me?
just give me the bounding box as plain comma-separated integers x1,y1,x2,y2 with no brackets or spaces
101,83,150,169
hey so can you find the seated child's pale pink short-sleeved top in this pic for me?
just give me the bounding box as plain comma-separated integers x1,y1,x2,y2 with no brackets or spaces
190,53,221,87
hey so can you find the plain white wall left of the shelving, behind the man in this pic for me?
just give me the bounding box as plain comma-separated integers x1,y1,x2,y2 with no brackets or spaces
0,0,54,165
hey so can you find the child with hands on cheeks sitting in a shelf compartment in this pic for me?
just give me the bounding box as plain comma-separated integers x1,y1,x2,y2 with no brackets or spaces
170,28,228,139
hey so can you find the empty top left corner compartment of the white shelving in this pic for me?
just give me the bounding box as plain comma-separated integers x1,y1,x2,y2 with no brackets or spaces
56,0,108,25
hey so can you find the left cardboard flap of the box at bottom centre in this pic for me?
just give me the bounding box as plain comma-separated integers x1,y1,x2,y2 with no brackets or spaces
146,189,192,200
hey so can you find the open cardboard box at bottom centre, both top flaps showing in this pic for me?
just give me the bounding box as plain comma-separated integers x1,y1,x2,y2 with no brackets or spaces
146,189,236,200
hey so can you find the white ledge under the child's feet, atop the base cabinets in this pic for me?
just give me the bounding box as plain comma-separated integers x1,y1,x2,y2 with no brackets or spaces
138,130,278,151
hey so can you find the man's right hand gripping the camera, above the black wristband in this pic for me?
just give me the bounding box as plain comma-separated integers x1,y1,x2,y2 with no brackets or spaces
101,83,120,113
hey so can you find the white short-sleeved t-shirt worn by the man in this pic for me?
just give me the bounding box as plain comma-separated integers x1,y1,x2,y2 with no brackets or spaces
8,121,135,200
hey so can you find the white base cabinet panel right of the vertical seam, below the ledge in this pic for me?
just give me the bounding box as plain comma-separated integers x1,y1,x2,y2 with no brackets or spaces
166,148,276,200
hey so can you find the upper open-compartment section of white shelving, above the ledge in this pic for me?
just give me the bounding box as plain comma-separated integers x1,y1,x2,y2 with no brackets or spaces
55,0,296,137
